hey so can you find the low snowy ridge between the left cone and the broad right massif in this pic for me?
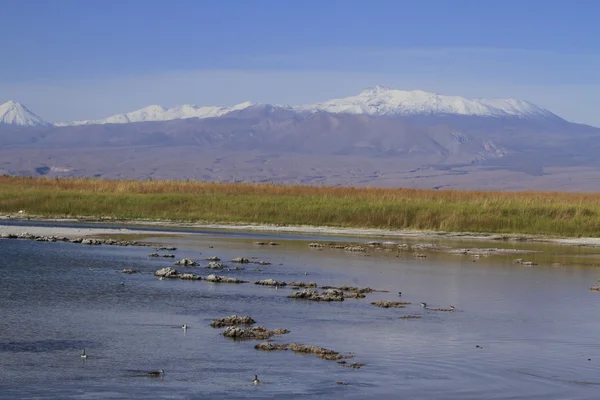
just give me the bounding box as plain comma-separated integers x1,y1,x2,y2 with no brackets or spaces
56,102,253,126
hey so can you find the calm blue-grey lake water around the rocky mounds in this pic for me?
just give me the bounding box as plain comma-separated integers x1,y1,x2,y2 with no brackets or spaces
0,223,600,400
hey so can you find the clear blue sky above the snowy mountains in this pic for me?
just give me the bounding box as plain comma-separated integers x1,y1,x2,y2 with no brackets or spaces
0,0,600,126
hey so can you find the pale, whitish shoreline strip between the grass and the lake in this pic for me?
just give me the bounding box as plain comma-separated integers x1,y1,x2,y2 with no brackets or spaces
0,215,600,247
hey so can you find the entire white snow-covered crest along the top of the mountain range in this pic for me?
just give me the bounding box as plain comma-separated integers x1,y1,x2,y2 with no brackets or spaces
0,85,564,127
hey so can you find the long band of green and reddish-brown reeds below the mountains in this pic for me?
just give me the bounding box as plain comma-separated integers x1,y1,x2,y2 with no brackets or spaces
0,176,600,237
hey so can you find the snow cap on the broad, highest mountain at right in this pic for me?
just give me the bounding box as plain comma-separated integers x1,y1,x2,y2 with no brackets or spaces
294,86,559,119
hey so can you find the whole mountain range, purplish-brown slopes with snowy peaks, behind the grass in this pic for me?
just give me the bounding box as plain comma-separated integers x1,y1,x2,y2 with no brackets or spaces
0,86,600,191
